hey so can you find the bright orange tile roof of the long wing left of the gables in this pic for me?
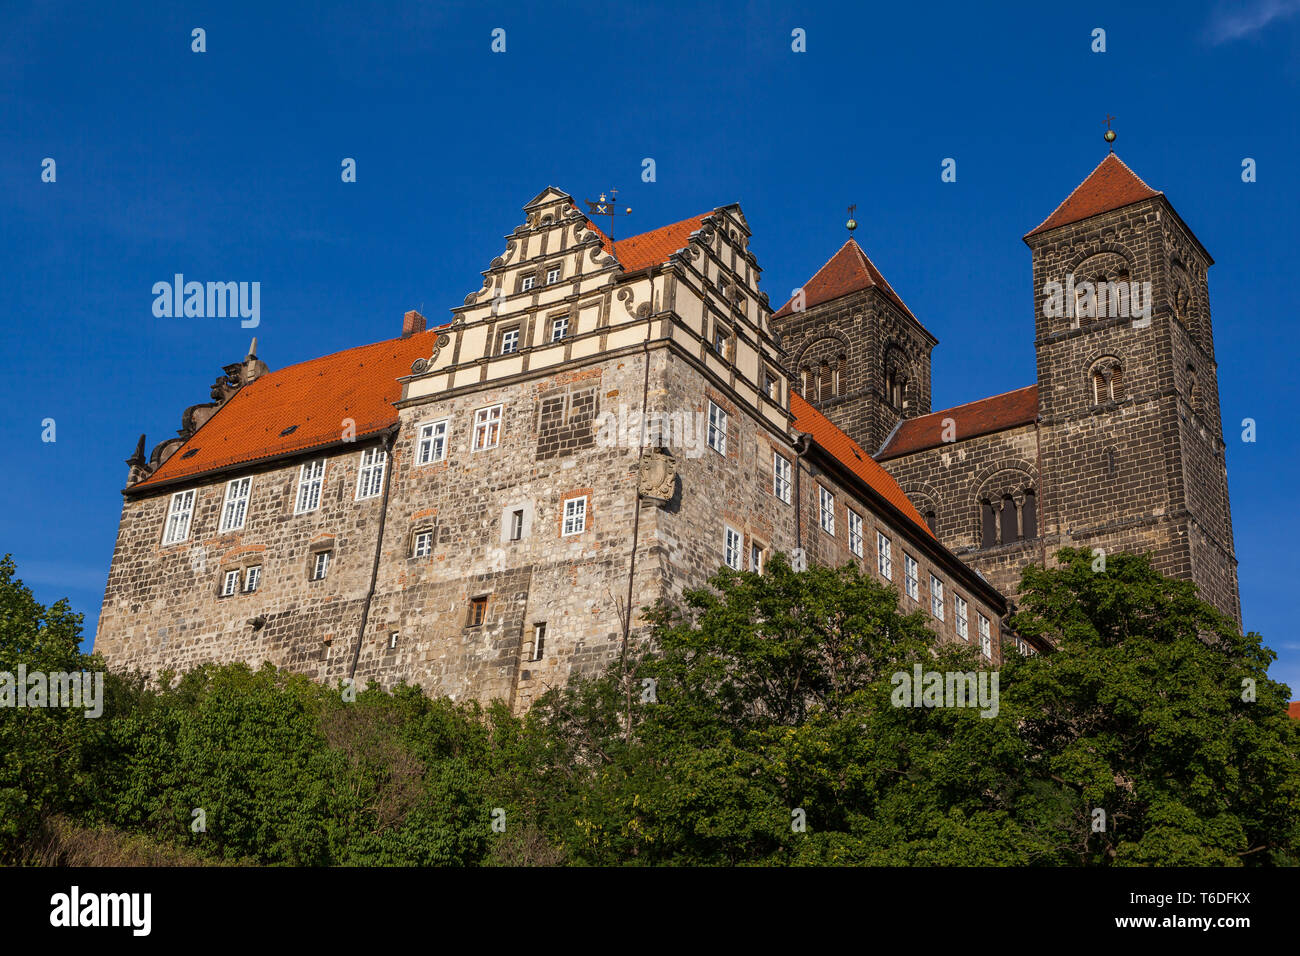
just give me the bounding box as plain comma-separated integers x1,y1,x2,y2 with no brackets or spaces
131,329,441,489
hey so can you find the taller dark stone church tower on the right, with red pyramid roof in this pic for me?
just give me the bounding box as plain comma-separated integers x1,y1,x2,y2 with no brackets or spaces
1024,152,1240,622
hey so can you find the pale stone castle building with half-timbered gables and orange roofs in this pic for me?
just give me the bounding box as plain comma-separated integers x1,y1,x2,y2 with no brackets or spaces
95,189,1019,710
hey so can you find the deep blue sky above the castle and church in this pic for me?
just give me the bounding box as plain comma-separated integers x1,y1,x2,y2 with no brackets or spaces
0,0,1300,693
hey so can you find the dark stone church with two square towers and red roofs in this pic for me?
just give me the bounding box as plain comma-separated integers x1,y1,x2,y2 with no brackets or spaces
772,152,1242,623
